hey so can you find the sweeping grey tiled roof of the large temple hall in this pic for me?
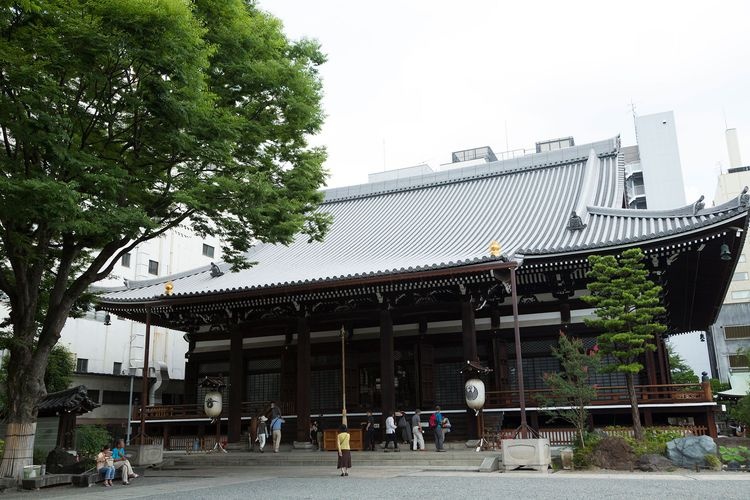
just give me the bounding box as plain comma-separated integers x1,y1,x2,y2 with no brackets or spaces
102,138,746,303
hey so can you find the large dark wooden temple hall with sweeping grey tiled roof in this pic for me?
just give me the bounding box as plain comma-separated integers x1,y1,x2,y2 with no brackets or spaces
100,137,750,442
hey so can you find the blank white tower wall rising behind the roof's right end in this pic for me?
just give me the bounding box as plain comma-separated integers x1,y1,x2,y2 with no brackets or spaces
635,111,694,210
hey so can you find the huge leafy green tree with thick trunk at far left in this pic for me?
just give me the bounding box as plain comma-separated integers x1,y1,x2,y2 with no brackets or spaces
0,0,330,477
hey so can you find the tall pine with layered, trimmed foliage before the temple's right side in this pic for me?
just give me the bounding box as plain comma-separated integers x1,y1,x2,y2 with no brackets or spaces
582,248,666,441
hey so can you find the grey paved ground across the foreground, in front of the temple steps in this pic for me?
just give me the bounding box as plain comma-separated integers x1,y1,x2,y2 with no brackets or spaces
1,466,750,500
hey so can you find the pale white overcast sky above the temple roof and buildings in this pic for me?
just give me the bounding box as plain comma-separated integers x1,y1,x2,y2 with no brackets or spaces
259,0,750,205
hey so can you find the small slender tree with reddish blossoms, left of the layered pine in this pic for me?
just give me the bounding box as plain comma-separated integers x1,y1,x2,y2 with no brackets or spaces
540,332,599,446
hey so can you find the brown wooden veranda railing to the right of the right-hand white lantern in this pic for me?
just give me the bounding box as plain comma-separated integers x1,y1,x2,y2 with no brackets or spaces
485,383,713,408
